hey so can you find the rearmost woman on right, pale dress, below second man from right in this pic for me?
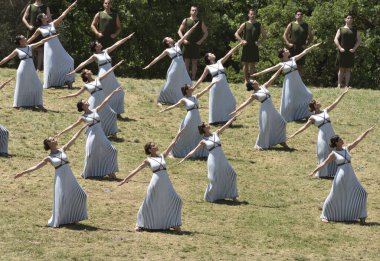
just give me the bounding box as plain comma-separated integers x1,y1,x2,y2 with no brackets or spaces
253,43,320,122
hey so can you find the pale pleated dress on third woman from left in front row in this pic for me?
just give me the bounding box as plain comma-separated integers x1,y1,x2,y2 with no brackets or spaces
203,132,238,202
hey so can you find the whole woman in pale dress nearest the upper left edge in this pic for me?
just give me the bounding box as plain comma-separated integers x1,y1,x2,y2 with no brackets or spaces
0,35,56,107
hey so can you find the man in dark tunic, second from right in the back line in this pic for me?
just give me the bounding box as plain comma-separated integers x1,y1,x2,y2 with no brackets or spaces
283,9,313,77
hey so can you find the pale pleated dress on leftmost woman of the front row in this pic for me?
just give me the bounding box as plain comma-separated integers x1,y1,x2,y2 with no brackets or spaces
48,150,87,227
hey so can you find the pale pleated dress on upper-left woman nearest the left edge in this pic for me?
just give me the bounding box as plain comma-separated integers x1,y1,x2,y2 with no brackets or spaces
13,45,43,107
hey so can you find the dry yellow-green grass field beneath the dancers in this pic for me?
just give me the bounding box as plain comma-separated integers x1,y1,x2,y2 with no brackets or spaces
0,69,380,260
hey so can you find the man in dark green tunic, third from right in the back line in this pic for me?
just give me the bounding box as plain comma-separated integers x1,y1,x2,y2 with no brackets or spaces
235,9,267,84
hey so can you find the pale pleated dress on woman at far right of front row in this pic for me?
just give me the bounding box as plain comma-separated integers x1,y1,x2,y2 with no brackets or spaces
321,148,367,221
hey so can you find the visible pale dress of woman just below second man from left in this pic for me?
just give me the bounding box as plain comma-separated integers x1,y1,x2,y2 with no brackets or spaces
98,63,125,114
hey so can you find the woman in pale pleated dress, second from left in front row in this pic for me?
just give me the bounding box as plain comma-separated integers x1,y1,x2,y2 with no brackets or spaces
119,129,183,232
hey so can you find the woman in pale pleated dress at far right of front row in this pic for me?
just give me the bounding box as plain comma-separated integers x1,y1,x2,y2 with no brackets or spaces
309,126,375,224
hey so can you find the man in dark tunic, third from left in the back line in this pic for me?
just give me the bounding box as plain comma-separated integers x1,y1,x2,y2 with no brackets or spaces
178,6,208,80
